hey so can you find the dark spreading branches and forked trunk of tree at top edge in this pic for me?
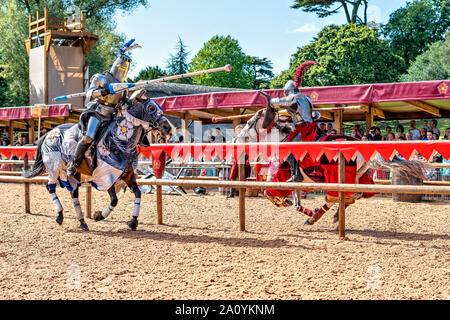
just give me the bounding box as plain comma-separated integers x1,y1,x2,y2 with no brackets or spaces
291,0,369,24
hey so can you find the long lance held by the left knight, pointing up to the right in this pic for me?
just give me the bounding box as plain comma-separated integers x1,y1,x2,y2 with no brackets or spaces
53,64,232,101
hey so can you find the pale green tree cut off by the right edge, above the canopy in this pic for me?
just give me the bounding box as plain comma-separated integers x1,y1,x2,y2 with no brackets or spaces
400,31,450,82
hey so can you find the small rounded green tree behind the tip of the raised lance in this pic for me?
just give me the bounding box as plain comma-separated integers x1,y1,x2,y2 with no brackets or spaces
189,35,252,89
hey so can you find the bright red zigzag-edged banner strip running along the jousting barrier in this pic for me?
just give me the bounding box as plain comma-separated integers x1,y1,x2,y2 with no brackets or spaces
0,140,450,161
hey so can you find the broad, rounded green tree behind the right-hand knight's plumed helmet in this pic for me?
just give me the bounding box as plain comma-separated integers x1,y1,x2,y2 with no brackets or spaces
270,24,405,88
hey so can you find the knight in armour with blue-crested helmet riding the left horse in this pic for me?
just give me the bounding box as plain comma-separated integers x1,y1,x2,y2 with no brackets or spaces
67,39,140,176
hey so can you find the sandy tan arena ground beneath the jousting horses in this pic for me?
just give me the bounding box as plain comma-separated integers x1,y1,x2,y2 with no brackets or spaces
0,183,450,300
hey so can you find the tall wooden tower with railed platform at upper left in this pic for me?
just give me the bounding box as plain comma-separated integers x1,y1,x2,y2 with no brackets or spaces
25,8,98,107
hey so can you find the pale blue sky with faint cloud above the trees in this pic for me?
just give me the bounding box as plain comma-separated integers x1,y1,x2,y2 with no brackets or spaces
115,0,407,78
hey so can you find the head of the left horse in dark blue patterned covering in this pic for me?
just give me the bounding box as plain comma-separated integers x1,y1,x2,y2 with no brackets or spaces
127,89,172,137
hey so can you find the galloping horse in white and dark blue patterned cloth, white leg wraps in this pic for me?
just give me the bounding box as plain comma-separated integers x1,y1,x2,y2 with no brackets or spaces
23,89,172,231
